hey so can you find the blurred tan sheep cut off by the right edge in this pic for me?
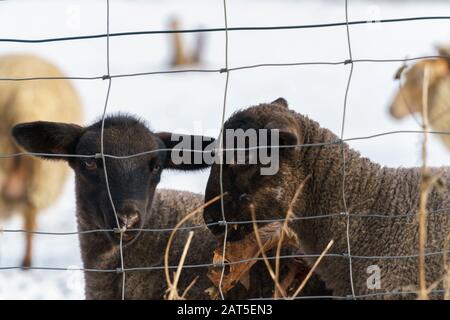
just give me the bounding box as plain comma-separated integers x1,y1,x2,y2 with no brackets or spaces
389,48,450,150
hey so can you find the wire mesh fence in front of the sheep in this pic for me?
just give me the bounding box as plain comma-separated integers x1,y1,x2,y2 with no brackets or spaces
0,0,450,300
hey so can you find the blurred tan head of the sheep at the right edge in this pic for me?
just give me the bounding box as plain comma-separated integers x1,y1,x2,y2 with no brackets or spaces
389,58,450,119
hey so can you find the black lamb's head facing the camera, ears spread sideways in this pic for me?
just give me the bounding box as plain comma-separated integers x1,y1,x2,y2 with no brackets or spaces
12,115,211,244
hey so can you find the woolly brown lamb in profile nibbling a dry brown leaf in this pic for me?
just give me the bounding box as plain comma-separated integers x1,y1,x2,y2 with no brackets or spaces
204,98,450,299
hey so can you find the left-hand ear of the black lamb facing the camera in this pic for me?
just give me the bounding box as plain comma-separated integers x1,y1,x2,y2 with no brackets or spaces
11,121,83,160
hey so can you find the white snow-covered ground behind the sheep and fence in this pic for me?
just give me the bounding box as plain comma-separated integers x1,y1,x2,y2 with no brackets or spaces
0,0,450,299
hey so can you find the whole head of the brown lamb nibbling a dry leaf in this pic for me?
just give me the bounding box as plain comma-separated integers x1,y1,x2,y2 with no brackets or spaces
204,98,303,241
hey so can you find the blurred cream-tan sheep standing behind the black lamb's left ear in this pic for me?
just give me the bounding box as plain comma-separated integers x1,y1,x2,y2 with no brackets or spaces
0,54,82,267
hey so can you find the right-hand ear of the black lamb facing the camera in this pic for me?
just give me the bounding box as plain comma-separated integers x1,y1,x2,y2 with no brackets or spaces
157,132,215,170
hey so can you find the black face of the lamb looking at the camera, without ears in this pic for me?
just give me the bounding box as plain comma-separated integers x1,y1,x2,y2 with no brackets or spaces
69,123,166,243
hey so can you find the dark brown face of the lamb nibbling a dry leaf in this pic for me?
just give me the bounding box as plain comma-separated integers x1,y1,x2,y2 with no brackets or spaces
203,100,301,241
